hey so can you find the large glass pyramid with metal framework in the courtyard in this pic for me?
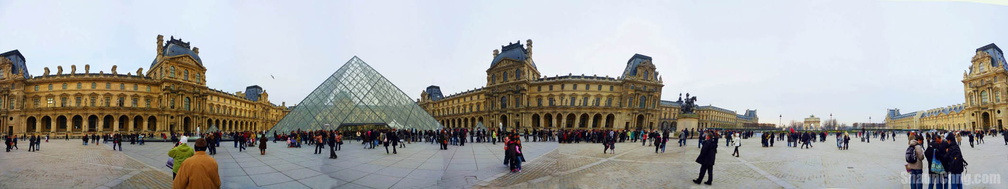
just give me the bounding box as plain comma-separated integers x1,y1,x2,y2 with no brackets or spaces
272,56,442,132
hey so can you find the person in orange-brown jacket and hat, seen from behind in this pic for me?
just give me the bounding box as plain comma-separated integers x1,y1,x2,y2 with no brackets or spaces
171,138,221,188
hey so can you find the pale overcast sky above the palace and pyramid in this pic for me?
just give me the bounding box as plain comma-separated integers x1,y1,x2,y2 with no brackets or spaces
0,0,1008,124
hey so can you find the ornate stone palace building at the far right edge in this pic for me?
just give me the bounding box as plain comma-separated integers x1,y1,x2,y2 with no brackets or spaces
886,43,1008,130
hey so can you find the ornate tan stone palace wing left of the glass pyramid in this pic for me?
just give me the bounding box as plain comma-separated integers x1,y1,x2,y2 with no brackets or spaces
0,35,288,135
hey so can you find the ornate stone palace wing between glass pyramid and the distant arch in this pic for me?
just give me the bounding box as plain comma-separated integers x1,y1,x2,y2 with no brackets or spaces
417,39,757,130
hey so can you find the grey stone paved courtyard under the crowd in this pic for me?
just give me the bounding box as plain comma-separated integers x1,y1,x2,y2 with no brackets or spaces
0,133,1008,188
